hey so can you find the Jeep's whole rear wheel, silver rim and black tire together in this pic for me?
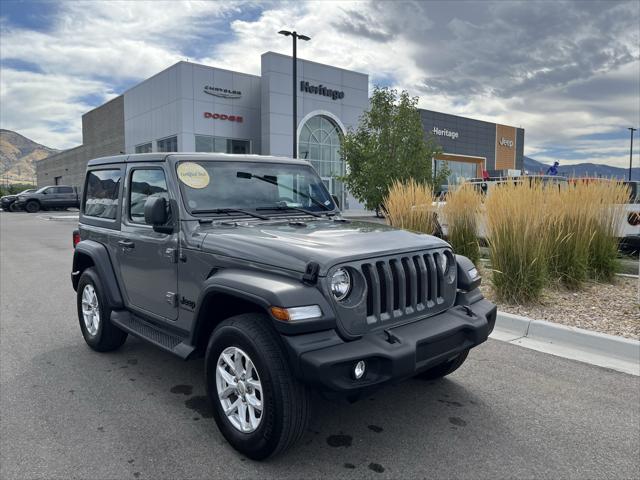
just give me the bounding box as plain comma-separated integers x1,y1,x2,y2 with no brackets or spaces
77,268,127,352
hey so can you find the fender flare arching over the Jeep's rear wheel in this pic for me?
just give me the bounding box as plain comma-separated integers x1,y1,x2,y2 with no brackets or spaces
71,240,124,309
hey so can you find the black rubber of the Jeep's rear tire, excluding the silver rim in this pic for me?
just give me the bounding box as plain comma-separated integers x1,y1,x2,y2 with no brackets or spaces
76,268,127,352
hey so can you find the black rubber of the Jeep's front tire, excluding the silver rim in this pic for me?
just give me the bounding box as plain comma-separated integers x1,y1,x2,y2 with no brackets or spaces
205,313,310,460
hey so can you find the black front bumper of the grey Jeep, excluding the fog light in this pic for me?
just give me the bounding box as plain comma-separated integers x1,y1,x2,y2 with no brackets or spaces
283,300,497,395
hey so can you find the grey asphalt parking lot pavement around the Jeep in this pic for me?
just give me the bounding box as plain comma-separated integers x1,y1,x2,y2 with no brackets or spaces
0,212,640,479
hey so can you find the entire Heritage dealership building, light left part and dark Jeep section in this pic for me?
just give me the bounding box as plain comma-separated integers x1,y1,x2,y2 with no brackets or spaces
36,52,524,210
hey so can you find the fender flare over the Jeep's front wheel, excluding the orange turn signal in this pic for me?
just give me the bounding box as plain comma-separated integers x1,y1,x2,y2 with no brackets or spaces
191,269,336,345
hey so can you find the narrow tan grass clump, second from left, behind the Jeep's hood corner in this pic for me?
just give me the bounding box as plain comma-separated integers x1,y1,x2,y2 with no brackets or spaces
442,183,482,264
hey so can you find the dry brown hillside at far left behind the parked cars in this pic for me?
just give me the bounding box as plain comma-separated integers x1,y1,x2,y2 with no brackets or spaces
0,129,58,183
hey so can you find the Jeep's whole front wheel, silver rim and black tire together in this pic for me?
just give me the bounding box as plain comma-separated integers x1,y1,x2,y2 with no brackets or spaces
205,314,310,460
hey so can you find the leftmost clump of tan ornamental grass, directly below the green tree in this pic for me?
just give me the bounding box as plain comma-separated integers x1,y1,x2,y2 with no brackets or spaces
384,179,438,235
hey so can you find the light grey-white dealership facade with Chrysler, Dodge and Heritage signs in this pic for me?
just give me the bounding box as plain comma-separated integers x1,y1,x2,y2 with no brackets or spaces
123,52,369,208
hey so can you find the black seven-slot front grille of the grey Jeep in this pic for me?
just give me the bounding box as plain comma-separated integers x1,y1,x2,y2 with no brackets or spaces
360,252,454,324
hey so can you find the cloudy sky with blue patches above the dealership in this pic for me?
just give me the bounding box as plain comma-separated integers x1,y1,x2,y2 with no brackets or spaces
0,0,640,167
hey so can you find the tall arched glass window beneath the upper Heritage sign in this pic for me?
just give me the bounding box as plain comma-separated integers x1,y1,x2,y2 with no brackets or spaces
298,115,345,204
